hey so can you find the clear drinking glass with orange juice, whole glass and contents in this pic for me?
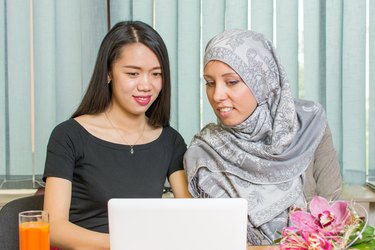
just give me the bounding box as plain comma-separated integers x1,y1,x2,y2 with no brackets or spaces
19,210,50,250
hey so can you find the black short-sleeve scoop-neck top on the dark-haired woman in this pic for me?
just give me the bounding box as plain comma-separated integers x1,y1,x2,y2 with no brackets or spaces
43,119,186,233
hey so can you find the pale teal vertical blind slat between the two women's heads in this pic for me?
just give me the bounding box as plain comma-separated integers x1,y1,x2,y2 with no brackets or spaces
174,0,201,141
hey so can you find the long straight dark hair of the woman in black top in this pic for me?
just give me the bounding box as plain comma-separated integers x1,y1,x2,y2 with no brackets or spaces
72,21,171,127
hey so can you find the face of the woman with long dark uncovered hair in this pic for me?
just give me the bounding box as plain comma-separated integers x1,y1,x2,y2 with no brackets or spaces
109,43,162,115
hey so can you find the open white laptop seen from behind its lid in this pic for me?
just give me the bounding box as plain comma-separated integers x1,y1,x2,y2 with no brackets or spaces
108,198,247,250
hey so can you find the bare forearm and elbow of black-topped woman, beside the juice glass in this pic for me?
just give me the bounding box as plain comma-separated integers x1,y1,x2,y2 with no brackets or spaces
44,177,109,250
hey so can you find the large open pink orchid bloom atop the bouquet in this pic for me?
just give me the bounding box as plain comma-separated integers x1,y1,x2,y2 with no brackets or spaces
290,196,350,235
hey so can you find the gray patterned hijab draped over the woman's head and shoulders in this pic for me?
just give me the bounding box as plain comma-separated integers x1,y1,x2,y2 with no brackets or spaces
184,30,326,245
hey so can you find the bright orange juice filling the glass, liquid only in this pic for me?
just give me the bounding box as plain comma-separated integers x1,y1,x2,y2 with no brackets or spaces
19,221,50,250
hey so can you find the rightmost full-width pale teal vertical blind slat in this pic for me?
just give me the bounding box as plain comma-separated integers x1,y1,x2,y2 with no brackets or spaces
342,0,366,183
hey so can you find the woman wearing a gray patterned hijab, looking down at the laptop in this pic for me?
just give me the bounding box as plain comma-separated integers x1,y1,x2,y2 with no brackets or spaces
184,30,341,245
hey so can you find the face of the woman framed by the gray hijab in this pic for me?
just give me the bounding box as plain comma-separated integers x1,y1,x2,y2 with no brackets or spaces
203,61,257,126
